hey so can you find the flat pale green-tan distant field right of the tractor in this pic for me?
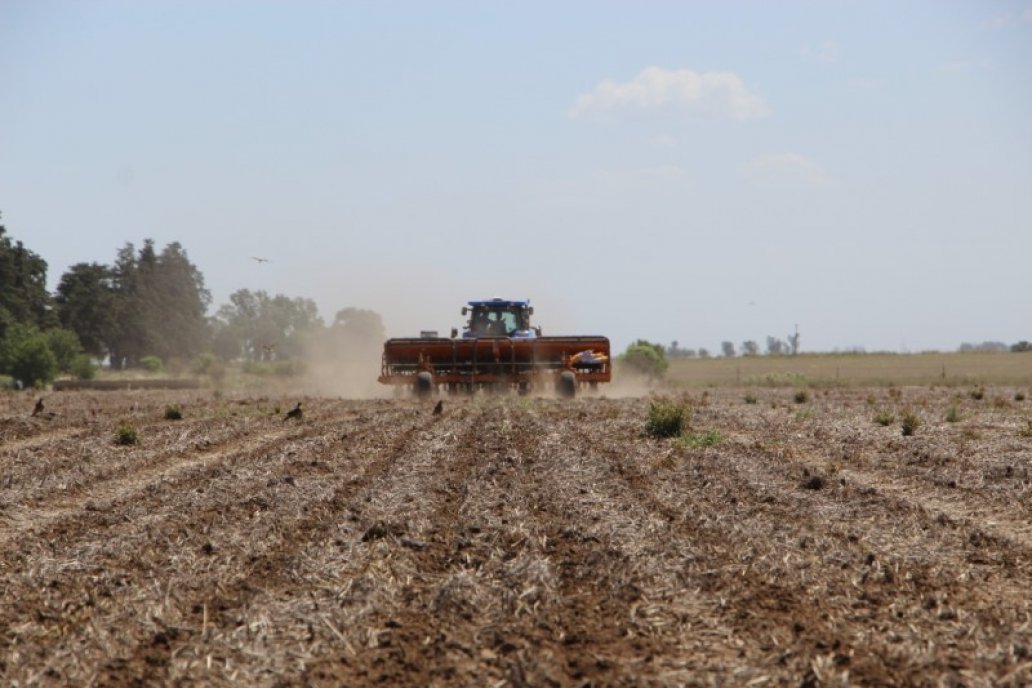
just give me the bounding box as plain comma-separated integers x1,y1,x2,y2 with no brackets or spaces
668,353,1032,387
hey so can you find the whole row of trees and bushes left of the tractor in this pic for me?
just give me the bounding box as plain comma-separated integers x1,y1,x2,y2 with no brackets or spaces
0,215,384,386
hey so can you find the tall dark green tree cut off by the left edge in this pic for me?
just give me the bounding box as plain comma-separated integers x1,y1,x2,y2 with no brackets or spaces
0,213,57,337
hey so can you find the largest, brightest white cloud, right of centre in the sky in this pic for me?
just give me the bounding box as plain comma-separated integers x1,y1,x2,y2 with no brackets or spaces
568,67,770,120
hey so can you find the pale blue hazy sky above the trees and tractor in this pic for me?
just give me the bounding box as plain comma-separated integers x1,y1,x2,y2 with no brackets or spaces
0,0,1032,352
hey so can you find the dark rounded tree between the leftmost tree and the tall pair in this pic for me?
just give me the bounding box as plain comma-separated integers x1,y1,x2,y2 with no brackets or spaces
54,263,118,358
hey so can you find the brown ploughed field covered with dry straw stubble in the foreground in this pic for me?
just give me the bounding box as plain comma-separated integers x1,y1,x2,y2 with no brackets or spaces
0,386,1032,686
